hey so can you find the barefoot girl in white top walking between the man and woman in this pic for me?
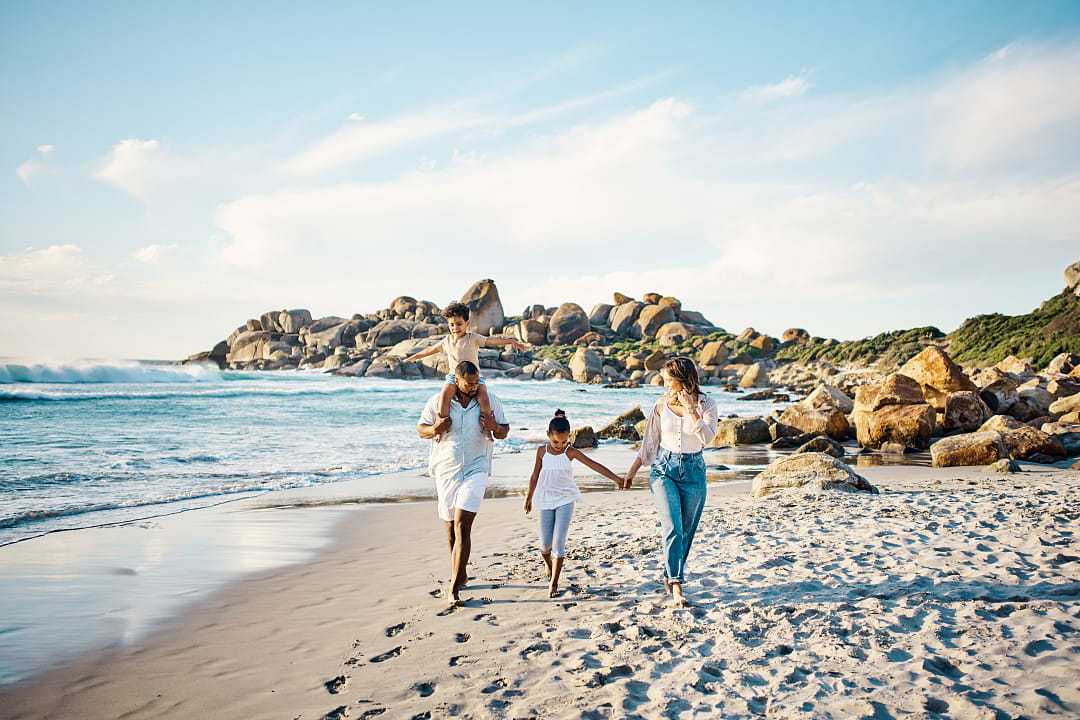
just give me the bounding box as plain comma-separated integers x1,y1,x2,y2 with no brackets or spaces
525,410,623,597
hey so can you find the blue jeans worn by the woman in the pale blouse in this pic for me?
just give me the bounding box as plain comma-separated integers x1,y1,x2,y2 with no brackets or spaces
649,448,706,583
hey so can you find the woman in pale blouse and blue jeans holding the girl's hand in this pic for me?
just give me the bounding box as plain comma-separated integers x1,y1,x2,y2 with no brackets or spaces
623,357,718,606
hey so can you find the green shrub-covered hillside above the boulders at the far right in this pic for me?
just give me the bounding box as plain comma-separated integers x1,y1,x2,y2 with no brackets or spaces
948,290,1080,368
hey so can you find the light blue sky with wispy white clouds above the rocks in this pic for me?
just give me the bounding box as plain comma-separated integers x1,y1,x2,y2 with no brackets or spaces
0,2,1080,358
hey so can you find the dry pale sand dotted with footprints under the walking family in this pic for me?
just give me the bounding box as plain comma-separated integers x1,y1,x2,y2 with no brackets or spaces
0,449,1080,720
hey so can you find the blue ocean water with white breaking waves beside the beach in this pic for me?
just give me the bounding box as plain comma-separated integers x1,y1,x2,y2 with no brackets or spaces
0,361,794,545
